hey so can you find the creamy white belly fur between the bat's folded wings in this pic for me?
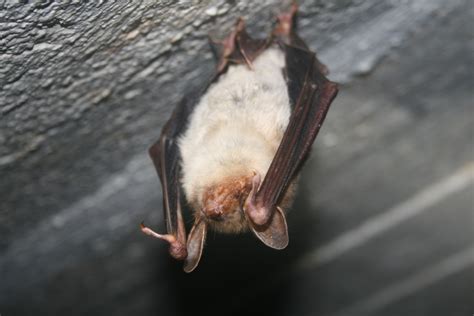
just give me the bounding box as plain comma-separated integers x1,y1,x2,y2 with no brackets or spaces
179,47,291,204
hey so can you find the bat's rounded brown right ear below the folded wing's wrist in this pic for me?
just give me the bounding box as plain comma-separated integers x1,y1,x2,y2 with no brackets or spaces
248,206,288,249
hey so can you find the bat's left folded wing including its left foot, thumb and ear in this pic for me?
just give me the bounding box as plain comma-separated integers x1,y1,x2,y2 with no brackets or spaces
142,19,270,272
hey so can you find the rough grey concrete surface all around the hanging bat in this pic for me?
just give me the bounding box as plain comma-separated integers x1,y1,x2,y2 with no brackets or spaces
0,0,474,315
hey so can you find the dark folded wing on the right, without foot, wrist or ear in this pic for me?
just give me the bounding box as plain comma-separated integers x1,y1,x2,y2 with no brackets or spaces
256,44,337,210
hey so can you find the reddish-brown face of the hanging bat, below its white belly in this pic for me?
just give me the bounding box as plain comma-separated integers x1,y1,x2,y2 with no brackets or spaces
201,175,252,233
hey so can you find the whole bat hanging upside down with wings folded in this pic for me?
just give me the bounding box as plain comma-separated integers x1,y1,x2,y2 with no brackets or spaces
141,5,337,272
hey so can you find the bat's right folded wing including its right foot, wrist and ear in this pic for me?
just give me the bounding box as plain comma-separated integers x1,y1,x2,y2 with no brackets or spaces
245,8,338,249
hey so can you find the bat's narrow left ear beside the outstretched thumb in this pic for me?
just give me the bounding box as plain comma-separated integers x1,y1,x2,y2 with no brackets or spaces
184,220,207,273
